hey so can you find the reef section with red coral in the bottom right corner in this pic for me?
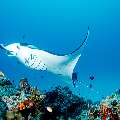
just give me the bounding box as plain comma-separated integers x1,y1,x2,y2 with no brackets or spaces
88,91,120,120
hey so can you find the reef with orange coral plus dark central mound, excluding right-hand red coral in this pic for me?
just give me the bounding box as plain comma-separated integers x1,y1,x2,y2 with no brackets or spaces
0,71,92,120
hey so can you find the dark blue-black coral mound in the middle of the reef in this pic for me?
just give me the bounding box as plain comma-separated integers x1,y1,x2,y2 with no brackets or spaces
39,86,88,120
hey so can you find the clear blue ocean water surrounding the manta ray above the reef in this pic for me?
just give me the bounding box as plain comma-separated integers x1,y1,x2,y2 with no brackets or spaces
0,0,120,101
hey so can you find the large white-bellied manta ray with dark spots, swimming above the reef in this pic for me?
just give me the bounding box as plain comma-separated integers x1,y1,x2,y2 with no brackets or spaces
0,28,89,83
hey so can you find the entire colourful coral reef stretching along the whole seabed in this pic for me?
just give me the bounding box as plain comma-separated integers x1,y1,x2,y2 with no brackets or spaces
0,72,120,120
